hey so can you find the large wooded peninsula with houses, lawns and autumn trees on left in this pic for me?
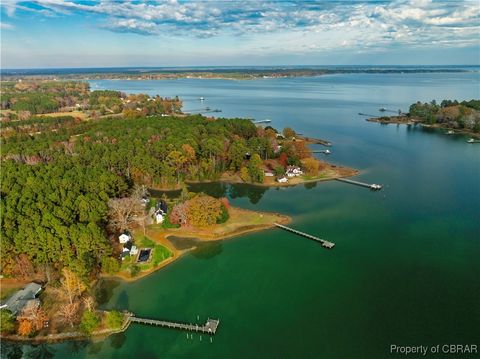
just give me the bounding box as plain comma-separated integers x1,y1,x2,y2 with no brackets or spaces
0,81,357,342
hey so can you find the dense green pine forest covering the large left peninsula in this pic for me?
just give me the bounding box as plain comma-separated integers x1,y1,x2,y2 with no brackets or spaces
1,109,308,279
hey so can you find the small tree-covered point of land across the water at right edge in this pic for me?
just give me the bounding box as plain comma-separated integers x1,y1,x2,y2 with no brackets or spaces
367,100,480,138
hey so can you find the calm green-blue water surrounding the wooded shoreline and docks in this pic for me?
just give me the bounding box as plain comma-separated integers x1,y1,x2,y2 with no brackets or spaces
5,73,480,359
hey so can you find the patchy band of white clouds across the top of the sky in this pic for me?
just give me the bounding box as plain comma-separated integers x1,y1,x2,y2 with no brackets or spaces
2,0,480,51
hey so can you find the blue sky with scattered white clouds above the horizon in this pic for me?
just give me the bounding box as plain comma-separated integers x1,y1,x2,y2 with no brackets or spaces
0,0,480,69
